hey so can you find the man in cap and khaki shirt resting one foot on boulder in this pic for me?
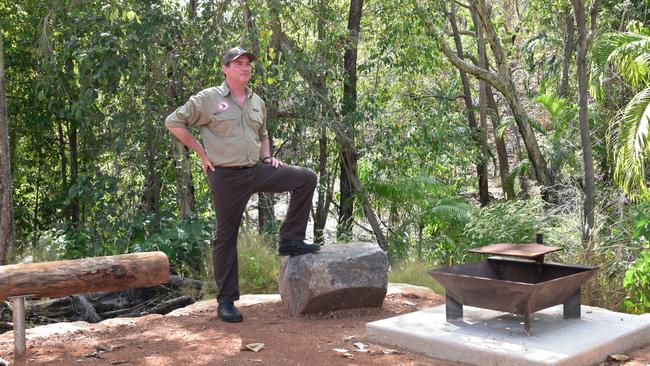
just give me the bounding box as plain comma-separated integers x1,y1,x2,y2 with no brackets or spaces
165,47,320,322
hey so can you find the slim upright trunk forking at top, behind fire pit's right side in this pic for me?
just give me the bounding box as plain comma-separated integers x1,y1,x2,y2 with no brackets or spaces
571,0,596,243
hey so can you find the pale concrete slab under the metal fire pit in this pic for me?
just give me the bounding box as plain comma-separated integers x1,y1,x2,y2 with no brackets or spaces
366,304,650,366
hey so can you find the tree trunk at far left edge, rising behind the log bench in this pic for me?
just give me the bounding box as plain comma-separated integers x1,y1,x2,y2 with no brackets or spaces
0,32,14,266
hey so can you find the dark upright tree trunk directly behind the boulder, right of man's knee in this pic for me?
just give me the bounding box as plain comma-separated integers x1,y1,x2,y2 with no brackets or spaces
337,0,363,237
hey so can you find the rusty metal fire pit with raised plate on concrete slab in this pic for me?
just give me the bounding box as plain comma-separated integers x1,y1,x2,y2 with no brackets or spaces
429,244,597,334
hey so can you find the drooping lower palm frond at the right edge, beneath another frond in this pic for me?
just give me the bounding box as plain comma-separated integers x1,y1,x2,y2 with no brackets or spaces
608,86,650,198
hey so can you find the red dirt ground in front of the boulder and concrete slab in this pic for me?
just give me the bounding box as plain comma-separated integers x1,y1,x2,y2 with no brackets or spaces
0,293,650,366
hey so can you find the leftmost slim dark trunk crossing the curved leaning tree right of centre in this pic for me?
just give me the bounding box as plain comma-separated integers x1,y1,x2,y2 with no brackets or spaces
447,1,490,206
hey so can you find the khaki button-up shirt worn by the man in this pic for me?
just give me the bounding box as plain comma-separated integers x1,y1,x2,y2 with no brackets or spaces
165,82,268,166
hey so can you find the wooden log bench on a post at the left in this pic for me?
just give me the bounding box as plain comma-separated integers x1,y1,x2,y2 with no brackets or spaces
0,252,169,360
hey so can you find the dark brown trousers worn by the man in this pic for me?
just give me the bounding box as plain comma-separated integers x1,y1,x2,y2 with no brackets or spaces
208,164,317,303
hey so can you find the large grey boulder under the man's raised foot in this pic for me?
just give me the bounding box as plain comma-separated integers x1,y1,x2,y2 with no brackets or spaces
280,242,388,314
